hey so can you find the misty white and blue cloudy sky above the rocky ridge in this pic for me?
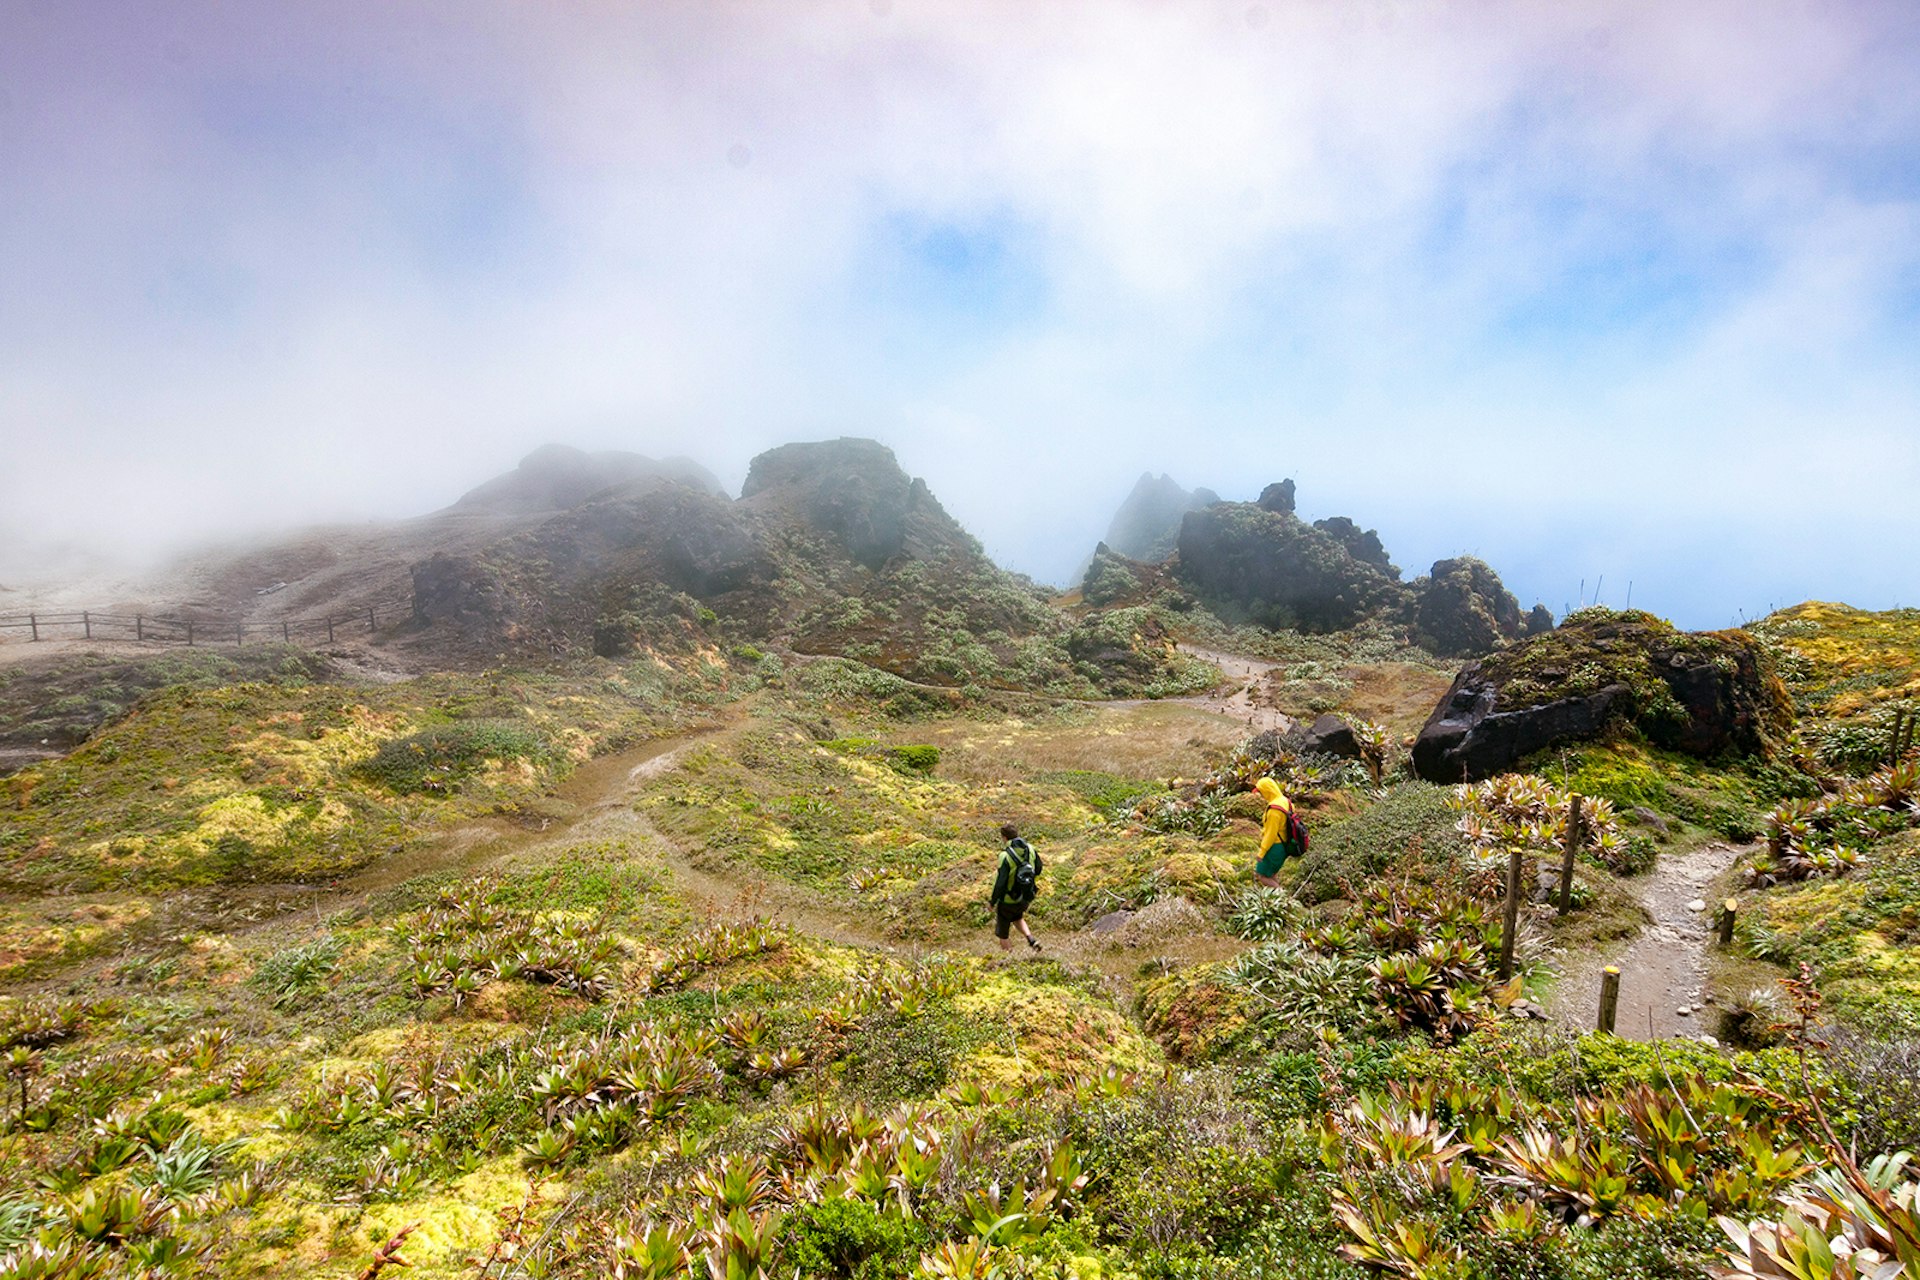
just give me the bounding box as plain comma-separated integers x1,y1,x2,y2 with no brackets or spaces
0,0,1920,626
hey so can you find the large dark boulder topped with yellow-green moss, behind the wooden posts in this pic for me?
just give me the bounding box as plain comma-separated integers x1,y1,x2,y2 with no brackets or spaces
1413,608,1793,783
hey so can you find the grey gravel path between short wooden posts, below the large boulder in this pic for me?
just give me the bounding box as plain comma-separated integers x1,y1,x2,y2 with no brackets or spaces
1555,844,1745,1040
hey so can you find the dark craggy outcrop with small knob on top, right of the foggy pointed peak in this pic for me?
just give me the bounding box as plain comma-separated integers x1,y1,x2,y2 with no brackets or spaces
1175,502,1405,631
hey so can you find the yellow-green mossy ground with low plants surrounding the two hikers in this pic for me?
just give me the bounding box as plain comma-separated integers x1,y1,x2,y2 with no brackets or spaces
0,624,1920,1280
